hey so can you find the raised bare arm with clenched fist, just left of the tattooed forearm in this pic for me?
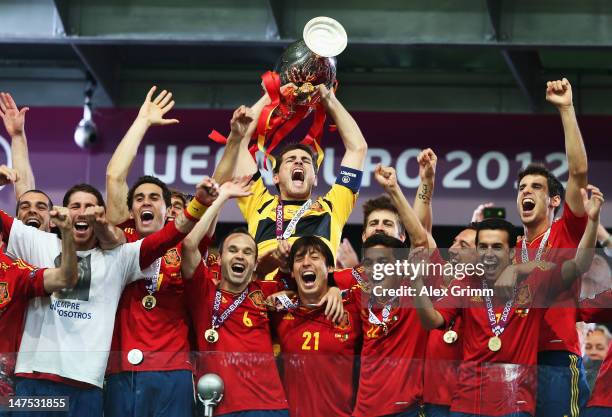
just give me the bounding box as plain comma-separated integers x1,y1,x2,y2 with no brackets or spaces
374,165,427,248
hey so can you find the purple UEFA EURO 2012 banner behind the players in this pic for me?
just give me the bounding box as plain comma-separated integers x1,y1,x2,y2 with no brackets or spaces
0,106,612,225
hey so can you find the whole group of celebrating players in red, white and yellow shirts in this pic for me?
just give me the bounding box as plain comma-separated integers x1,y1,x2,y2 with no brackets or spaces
0,79,612,417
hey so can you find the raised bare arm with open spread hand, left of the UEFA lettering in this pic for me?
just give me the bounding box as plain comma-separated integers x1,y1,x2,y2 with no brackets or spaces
106,86,179,224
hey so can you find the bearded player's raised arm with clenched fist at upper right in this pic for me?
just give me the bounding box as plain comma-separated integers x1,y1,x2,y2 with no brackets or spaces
546,78,588,217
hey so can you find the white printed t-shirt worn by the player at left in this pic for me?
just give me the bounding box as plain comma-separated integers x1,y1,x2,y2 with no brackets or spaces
7,219,156,388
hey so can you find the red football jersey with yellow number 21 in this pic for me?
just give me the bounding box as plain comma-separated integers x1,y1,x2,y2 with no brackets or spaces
274,292,361,417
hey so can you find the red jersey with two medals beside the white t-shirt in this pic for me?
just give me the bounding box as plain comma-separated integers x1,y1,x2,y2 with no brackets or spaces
107,228,193,373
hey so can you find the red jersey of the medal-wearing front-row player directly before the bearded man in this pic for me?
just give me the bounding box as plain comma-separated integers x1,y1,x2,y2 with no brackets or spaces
438,265,561,416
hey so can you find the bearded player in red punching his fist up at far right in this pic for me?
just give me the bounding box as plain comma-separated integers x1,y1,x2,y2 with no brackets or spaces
508,78,589,417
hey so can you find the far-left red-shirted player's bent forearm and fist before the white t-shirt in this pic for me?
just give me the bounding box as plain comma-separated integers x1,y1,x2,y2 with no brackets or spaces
43,206,79,294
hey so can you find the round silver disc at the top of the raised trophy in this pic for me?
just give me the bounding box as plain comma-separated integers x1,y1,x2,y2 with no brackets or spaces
303,16,347,58
